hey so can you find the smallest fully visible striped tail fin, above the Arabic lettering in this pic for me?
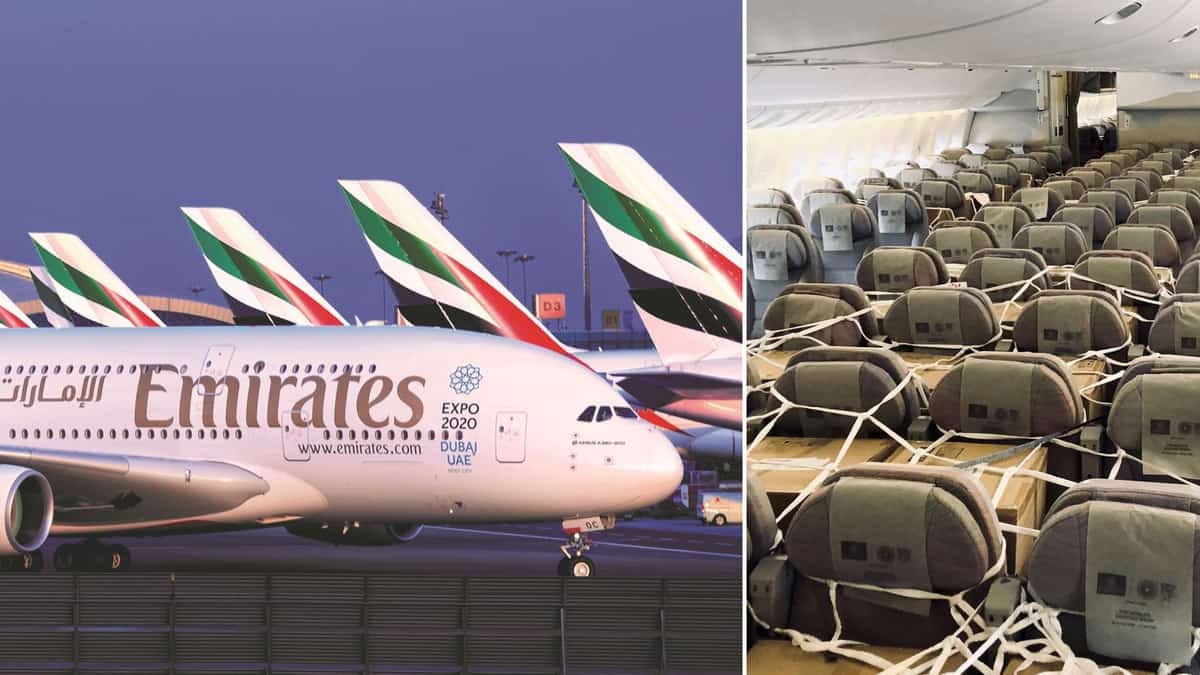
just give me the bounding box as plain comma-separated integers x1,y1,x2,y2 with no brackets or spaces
29,232,166,328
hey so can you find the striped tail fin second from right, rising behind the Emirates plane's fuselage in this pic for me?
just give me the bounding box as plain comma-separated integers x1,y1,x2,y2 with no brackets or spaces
338,180,570,354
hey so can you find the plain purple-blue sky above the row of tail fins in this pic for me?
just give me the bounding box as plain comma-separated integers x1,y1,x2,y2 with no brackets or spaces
0,0,743,328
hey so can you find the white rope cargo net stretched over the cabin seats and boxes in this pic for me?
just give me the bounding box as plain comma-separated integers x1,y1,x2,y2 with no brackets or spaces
746,264,1200,675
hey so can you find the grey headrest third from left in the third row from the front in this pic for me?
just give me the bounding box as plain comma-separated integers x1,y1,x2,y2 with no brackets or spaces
1013,288,1129,357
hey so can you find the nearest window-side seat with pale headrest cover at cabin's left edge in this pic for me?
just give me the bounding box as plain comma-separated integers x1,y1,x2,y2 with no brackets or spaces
746,223,824,338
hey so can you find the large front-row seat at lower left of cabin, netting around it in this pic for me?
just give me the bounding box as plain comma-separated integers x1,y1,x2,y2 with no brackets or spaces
784,462,1003,649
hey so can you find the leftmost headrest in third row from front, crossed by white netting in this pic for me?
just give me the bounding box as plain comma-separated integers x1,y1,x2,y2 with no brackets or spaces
762,283,880,350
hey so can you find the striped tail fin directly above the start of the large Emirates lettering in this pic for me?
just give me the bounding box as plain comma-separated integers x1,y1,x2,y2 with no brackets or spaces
182,207,348,325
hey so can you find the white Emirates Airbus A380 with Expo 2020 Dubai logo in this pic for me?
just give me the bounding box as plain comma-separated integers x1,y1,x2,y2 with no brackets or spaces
0,319,682,575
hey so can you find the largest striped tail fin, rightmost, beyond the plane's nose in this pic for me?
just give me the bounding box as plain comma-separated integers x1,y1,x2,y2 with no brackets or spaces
559,143,743,363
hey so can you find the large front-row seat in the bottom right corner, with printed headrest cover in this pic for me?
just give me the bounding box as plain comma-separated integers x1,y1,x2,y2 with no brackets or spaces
1026,479,1200,673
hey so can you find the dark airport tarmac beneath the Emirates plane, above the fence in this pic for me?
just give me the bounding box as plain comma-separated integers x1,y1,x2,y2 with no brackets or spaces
35,518,743,577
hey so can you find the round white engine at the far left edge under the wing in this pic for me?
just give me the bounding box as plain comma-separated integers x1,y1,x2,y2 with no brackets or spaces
0,464,54,555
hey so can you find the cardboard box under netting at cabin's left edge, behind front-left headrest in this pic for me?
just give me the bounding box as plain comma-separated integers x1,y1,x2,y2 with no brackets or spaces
746,436,907,531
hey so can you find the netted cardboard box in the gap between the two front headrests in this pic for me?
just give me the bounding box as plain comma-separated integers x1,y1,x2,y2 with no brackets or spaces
892,442,1046,574
